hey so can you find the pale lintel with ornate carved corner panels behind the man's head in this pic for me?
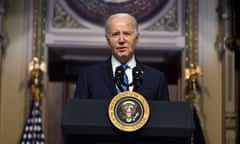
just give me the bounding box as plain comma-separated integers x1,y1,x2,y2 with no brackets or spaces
46,0,185,50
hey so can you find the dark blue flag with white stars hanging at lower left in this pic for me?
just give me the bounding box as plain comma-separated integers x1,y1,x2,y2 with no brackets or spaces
19,100,45,144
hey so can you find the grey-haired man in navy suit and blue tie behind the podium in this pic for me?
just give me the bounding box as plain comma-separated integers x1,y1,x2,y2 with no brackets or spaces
74,13,169,101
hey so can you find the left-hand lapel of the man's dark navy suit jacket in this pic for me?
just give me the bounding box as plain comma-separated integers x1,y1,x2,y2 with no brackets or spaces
102,58,117,97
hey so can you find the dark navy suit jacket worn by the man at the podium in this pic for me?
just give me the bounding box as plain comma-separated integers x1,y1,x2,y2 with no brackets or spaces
74,58,169,101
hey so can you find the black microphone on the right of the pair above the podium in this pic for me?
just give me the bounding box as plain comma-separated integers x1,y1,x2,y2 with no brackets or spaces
132,66,143,91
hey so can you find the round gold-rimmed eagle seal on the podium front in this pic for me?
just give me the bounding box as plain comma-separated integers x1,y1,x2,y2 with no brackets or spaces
108,91,150,132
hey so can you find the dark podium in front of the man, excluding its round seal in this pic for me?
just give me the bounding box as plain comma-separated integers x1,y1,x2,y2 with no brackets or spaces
61,99,194,144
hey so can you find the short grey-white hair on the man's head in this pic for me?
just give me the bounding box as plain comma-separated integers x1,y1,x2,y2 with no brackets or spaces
105,13,138,35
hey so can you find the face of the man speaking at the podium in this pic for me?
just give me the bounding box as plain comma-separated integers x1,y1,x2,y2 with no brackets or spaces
106,17,139,63
